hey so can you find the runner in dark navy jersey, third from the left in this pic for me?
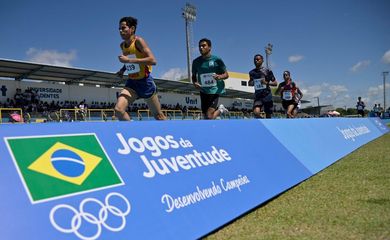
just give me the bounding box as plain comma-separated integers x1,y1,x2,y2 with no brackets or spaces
248,54,278,118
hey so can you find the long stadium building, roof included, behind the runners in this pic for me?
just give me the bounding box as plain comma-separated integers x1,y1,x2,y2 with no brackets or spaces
0,59,281,122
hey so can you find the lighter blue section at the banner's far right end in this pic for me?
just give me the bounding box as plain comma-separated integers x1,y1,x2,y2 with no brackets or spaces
263,118,389,174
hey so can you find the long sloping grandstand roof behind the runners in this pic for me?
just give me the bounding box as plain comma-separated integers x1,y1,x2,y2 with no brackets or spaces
0,59,253,99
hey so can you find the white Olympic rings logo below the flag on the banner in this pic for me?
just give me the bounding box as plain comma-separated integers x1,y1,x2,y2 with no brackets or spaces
50,192,131,240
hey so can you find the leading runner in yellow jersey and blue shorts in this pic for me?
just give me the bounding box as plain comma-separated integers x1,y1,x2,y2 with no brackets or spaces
115,17,166,121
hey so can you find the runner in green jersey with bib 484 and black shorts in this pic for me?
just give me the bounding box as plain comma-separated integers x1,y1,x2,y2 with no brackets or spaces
192,38,229,119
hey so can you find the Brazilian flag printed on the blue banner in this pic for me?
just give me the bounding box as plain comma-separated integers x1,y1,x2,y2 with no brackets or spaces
6,134,123,203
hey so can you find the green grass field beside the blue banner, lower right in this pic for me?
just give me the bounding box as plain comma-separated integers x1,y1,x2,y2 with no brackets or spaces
205,134,390,240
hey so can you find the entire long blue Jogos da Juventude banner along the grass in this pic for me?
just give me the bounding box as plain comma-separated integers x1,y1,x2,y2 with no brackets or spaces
0,119,388,239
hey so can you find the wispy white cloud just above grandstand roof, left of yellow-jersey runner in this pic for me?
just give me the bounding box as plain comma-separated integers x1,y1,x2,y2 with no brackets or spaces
26,48,77,67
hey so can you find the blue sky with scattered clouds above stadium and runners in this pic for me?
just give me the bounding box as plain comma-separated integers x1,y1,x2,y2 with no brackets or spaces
0,0,390,109
